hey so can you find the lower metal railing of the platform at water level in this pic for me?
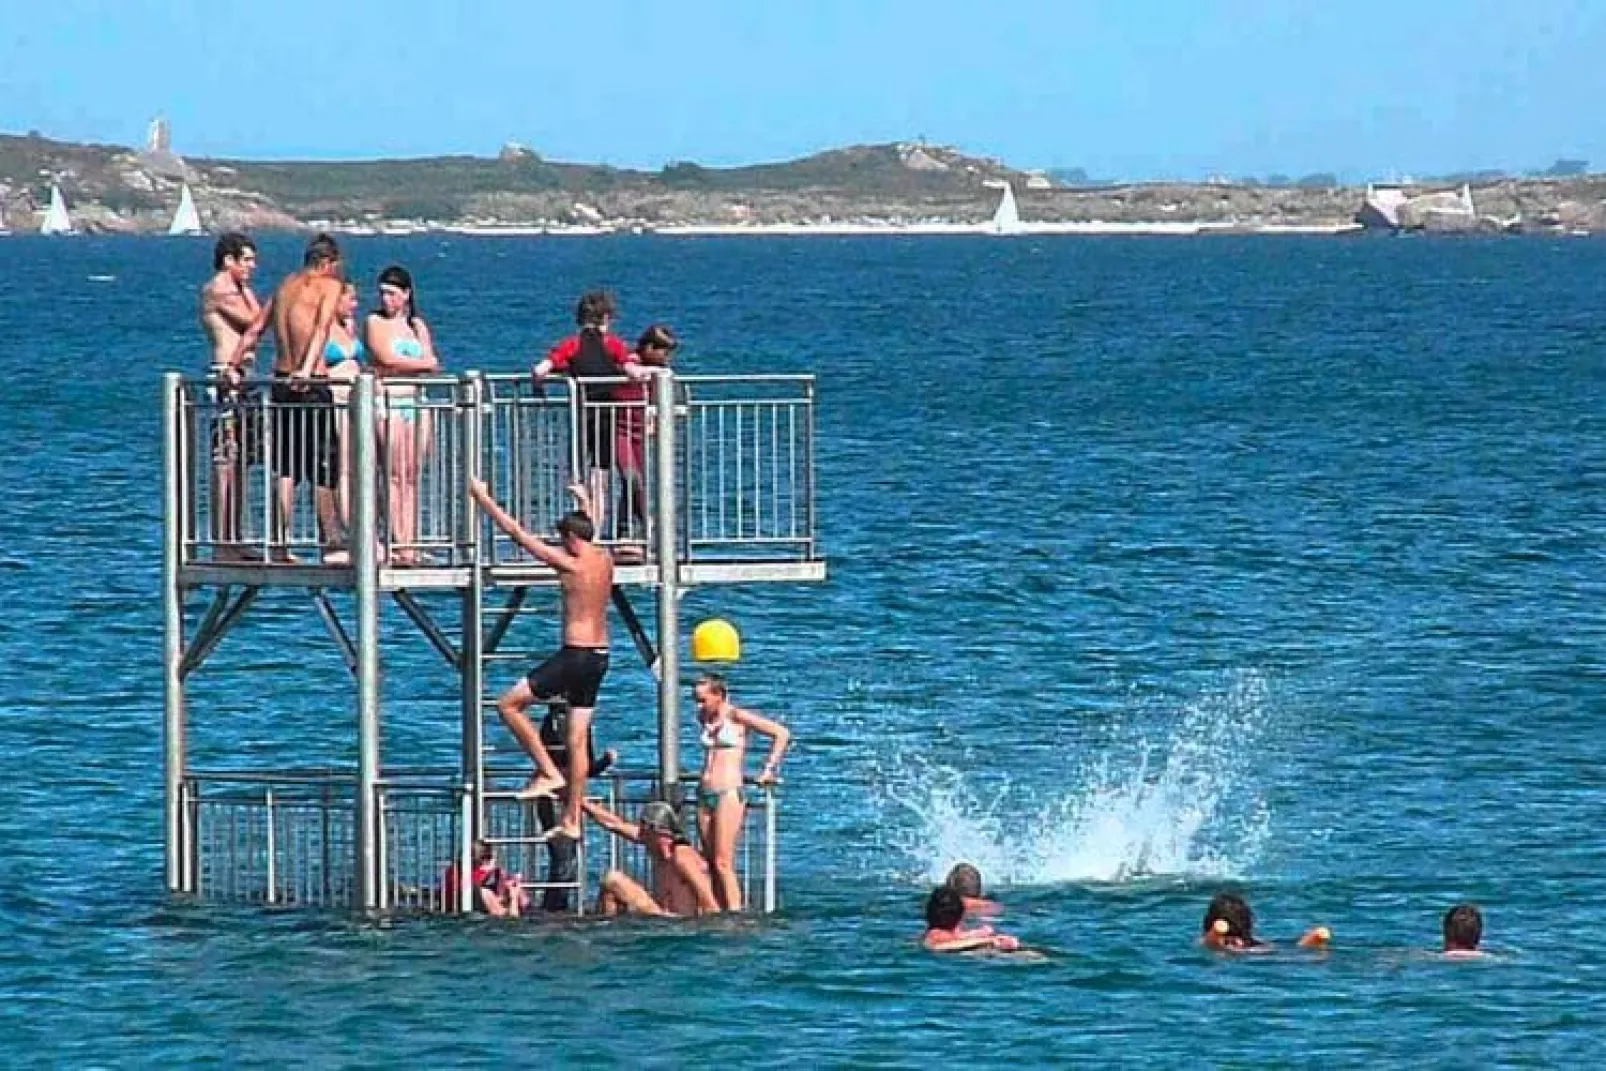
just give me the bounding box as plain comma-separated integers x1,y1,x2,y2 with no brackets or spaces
181,769,779,914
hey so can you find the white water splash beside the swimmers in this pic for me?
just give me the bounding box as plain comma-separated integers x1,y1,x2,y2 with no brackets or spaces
882,673,1270,885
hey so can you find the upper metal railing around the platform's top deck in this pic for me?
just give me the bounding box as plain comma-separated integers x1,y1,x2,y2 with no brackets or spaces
170,376,817,567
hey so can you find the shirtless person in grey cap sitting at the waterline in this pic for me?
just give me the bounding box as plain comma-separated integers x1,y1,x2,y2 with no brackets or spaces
583,800,719,918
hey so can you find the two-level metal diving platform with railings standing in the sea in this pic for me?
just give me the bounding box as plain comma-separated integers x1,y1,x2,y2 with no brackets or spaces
162,373,825,914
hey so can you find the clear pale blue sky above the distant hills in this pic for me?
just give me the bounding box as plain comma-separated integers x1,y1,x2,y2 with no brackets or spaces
0,0,1606,178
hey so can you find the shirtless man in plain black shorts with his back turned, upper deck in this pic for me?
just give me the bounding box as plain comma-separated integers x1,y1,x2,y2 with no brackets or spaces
260,234,350,565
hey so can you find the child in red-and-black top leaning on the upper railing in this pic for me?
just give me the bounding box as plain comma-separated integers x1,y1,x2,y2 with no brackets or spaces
530,291,652,545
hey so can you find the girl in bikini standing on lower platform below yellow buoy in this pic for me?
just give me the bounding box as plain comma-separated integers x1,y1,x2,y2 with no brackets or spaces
694,673,792,910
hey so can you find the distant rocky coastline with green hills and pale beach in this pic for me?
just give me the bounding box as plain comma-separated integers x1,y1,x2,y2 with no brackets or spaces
0,135,1606,236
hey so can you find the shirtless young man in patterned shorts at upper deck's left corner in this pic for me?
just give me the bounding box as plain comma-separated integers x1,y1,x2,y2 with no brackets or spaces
201,231,262,562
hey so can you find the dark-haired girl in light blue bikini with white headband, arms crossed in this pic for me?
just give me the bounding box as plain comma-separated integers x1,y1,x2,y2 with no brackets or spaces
368,265,440,565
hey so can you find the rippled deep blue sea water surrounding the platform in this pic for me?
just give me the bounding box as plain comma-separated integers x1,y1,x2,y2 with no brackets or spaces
0,238,1606,1066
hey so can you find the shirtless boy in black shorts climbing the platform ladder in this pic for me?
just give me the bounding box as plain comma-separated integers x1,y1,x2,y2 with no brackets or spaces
469,480,613,840
